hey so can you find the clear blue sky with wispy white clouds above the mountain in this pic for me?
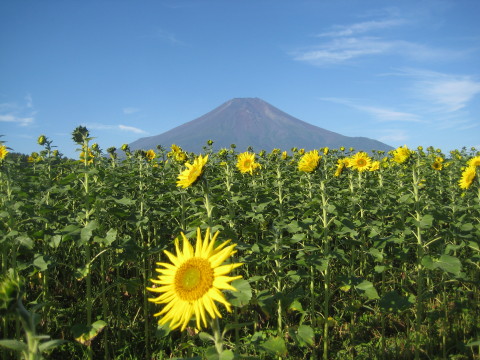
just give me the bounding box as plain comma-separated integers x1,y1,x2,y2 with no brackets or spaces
0,0,480,157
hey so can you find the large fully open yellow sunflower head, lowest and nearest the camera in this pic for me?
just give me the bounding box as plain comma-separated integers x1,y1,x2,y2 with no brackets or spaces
147,228,242,331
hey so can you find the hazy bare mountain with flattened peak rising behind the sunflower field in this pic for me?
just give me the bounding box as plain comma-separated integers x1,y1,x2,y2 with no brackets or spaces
129,98,393,153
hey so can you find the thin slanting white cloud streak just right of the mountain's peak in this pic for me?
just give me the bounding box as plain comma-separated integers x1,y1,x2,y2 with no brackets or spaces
321,97,423,122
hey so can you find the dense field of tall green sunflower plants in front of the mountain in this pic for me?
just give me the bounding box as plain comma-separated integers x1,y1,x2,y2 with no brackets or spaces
0,127,480,360
